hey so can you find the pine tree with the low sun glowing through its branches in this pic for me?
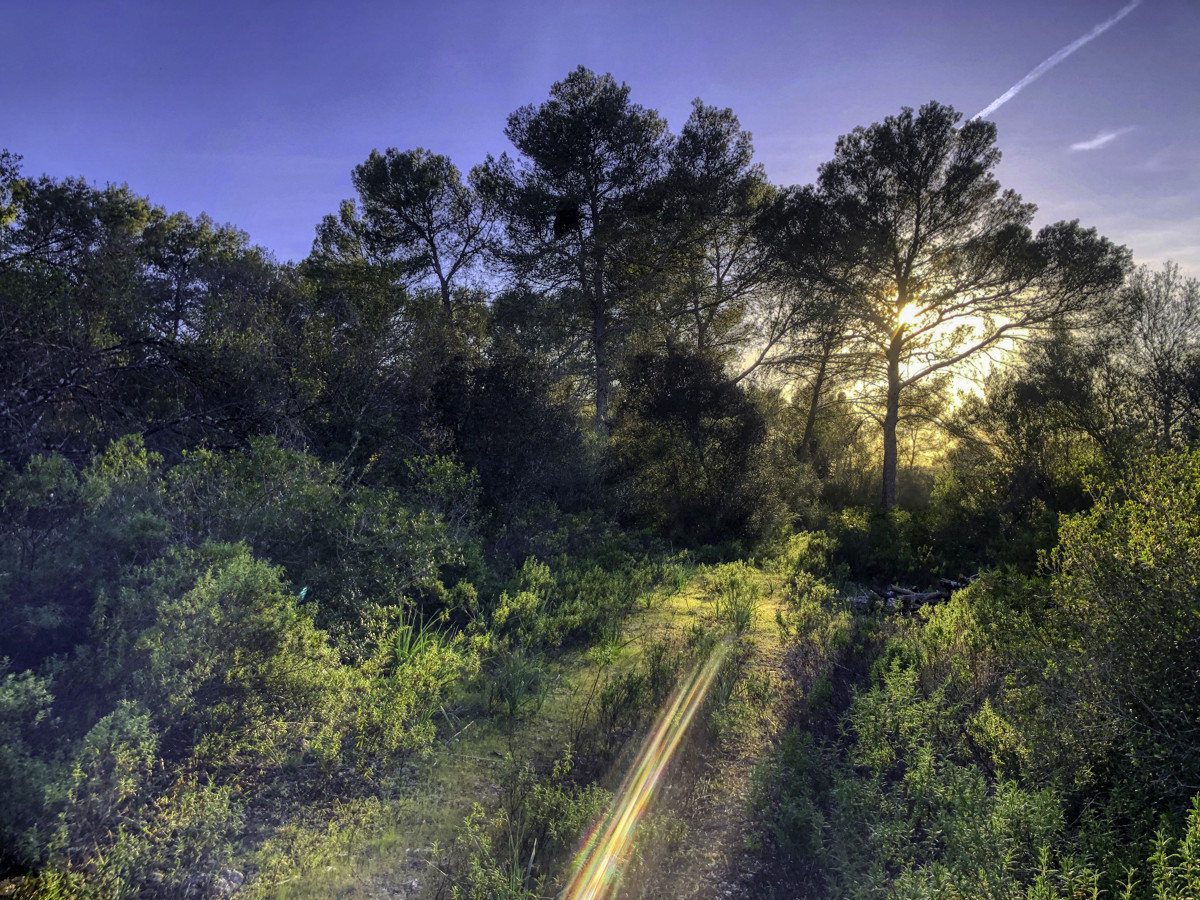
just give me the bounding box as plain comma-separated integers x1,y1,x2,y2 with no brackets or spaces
782,103,1129,508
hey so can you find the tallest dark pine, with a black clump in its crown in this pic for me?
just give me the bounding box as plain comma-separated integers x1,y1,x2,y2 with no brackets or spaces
478,66,671,430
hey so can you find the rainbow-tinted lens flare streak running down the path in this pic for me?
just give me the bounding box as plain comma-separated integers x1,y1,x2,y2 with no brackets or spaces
562,646,725,900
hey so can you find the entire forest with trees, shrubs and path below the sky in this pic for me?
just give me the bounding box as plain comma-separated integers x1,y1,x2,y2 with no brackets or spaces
0,67,1200,900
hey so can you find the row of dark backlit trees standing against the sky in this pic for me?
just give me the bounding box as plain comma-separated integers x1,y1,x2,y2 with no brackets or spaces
0,67,1152,525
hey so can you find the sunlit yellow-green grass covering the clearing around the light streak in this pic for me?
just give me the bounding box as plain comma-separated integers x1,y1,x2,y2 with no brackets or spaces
267,556,801,900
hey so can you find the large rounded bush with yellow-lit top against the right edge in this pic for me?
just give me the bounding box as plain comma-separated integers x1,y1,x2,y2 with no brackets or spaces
1046,452,1200,811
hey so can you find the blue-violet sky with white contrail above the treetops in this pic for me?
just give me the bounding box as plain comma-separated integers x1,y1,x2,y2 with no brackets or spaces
0,0,1200,277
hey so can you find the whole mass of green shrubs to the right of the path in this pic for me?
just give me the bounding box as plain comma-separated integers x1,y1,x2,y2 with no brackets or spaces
760,455,1200,898
